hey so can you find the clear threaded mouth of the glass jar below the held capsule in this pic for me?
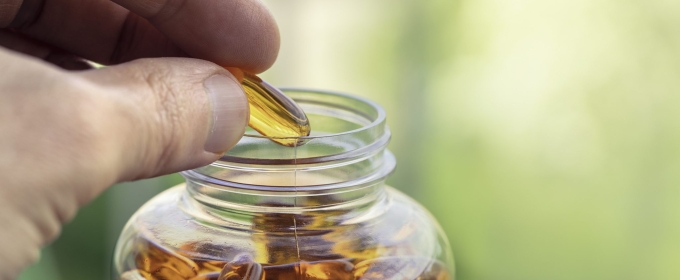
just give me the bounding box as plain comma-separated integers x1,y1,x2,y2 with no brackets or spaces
182,89,396,196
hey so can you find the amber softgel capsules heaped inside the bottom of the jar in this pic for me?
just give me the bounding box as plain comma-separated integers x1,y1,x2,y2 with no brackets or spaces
121,237,452,280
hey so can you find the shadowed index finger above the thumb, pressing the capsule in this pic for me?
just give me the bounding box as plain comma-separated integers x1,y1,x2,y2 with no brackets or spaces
4,0,279,73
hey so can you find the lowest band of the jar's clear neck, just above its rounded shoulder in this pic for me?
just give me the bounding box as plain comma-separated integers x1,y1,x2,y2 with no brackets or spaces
179,180,389,233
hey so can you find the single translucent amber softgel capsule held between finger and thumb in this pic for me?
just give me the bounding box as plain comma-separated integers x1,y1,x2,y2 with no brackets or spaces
241,73,311,147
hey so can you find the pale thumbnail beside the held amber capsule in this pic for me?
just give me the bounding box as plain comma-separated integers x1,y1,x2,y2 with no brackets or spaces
203,75,250,153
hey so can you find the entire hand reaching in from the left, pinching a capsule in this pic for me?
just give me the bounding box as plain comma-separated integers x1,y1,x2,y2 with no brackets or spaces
0,0,279,279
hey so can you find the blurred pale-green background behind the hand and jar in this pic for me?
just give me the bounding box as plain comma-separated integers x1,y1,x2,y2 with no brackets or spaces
21,0,680,280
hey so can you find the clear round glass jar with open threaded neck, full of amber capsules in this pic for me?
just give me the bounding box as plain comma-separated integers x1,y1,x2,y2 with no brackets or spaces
113,90,454,280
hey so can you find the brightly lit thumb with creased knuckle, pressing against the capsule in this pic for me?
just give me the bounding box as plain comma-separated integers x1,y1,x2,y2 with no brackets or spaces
79,58,249,181
